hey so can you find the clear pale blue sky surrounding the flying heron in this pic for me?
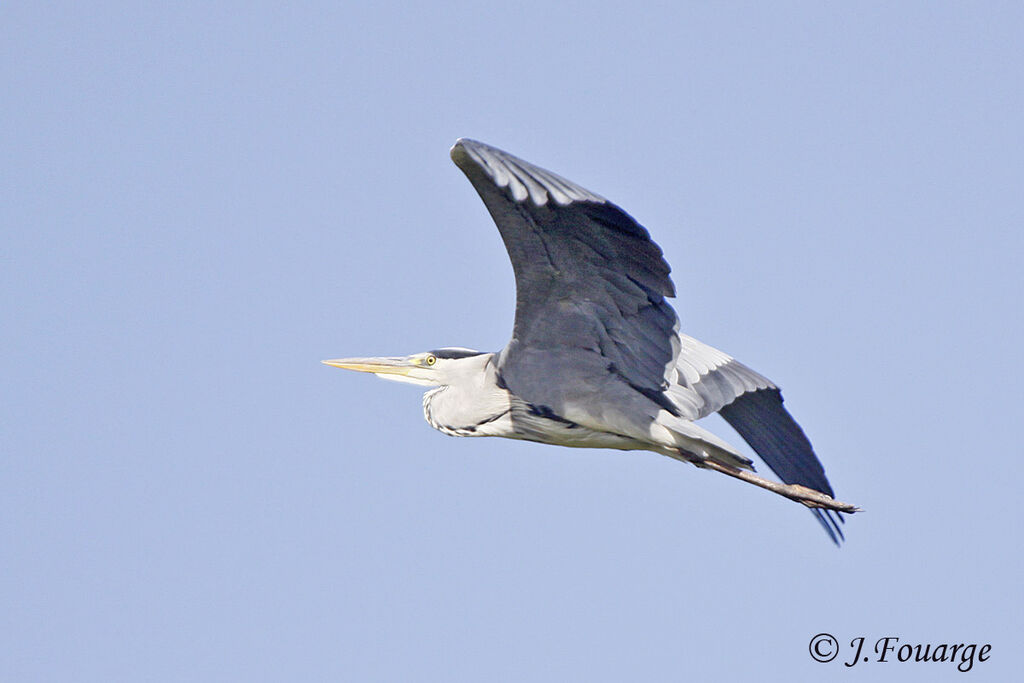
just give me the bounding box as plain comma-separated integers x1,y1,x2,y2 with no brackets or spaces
0,1,1024,681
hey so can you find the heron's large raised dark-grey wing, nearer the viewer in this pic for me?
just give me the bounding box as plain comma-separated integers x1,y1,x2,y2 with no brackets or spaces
452,139,679,428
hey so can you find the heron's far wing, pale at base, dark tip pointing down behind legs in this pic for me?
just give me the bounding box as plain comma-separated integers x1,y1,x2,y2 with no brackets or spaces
669,334,843,543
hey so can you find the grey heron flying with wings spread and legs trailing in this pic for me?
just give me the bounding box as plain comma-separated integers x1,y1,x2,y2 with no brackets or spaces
324,138,857,544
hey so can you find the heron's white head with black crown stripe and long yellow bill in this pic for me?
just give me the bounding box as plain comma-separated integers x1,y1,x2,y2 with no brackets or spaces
322,347,489,386
